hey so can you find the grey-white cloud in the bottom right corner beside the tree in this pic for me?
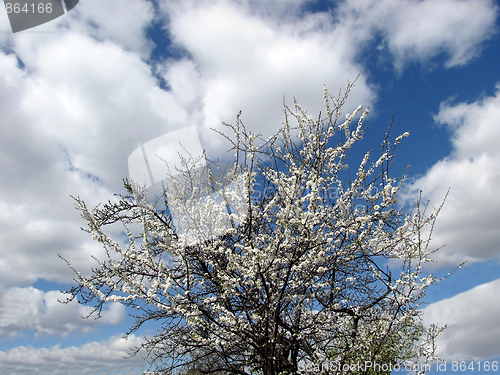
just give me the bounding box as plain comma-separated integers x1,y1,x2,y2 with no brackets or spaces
423,279,500,361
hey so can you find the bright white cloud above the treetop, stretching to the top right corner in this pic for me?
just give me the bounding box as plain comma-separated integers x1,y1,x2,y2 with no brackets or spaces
160,0,497,149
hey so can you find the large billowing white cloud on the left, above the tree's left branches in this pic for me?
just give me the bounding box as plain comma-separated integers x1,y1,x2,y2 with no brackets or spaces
0,31,187,286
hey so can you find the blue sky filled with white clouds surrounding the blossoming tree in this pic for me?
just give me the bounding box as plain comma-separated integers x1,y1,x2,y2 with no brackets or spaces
0,0,500,374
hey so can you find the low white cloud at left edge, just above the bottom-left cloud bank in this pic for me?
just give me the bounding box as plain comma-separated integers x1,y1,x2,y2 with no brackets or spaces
0,287,125,337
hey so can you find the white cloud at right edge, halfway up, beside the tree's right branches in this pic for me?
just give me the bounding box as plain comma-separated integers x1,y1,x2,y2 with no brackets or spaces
400,84,500,264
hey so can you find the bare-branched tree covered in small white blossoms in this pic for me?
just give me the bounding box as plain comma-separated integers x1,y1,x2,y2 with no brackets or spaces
62,84,450,375
